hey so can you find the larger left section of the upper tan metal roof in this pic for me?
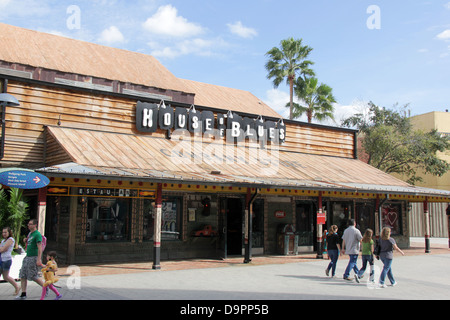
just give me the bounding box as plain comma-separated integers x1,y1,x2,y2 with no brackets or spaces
0,23,189,93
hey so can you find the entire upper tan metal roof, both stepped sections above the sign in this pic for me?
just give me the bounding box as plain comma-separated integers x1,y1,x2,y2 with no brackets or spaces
0,23,281,118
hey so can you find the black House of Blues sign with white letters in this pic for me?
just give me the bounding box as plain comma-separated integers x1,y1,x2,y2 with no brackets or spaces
136,101,286,144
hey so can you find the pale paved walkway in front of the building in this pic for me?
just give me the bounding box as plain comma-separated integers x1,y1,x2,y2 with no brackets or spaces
0,238,450,301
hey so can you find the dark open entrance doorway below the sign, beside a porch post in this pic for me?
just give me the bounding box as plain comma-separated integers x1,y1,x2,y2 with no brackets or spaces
218,198,244,259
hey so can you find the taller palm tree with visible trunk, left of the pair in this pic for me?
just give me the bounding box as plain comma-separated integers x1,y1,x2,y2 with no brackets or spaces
266,38,314,119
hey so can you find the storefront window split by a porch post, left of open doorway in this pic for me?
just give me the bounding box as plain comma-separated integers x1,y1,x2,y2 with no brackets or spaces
143,197,183,241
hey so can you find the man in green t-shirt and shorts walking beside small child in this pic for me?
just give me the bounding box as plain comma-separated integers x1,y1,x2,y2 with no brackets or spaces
16,219,44,300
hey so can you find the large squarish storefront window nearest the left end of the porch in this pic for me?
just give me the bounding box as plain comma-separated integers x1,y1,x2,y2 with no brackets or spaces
86,198,131,241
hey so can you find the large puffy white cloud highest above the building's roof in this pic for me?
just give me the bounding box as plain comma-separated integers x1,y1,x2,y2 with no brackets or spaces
143,4,204,38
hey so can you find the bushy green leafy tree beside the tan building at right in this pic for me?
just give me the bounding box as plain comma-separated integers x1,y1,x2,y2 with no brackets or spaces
342,102,450,184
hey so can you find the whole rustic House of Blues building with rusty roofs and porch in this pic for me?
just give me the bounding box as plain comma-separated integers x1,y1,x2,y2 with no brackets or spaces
0,24,450,266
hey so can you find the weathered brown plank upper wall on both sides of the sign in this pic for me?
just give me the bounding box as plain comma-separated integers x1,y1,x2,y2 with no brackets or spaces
2,81,354,167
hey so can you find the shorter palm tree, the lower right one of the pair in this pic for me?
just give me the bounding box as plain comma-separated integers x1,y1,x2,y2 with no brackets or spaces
286,77,336,123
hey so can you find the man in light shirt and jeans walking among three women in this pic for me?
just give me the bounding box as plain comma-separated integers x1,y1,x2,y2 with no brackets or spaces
342,219,362,283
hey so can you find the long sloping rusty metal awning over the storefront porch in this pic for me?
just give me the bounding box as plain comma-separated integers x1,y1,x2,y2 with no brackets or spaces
37,127,450,201
